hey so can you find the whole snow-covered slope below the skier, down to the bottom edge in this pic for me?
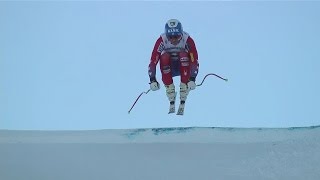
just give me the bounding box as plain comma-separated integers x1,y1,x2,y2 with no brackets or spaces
0,126,320,180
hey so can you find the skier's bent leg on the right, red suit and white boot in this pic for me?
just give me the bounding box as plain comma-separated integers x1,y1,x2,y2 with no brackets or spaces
179,52,190,102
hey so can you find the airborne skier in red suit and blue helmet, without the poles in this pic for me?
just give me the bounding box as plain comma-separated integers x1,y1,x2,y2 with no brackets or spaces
148,19,199,115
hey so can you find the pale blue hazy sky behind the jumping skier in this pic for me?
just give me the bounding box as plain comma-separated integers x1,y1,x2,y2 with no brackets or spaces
0,1,320,130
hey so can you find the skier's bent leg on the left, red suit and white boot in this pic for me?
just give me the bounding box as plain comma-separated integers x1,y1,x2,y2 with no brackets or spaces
160,53,176,102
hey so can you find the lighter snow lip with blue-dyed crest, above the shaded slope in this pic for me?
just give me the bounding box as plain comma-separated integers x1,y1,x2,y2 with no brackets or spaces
0,126,320,143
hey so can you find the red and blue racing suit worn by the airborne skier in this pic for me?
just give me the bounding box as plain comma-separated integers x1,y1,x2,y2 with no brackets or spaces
148,32,199,85
